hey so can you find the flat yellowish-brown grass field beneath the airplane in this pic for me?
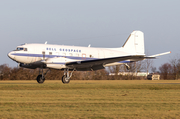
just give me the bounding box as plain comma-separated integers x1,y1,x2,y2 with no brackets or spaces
0,80,180,119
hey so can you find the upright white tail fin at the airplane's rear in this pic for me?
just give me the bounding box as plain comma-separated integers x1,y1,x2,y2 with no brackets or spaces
122,31,144,55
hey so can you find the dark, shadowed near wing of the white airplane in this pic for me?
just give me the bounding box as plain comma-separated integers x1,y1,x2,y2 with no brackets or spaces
66,55,150,71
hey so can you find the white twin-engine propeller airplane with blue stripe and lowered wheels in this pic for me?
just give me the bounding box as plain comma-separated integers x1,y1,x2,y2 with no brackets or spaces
8,31,171,84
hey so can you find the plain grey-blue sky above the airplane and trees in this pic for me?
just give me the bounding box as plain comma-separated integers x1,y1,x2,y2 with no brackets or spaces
0,0,180,69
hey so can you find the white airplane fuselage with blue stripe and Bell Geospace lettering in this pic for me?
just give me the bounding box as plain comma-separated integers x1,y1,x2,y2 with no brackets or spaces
8,44,135,69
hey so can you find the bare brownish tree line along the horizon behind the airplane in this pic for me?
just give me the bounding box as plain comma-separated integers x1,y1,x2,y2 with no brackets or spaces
0,55,180,80
